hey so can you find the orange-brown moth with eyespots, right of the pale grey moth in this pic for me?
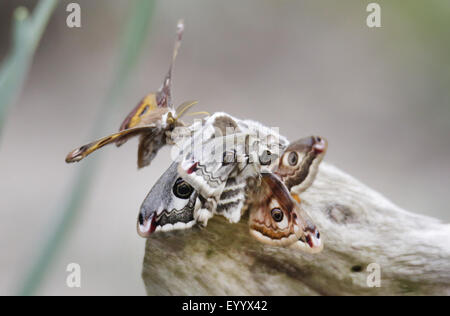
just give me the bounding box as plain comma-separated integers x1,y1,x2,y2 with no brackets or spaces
253,136,328,253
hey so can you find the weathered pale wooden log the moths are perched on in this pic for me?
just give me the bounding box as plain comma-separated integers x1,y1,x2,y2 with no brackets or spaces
142,163,450,295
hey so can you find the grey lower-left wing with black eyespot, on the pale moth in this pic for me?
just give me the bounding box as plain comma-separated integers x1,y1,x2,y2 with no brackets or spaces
137,163,200,237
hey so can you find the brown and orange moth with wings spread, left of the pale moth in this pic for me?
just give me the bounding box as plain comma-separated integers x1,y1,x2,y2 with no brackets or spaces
66,21,196,168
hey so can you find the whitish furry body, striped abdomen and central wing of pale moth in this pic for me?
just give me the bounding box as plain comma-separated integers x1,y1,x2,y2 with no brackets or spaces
179,113,287,223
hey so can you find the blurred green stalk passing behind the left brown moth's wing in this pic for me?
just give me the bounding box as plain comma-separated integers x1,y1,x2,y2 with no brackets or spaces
19,0,154,295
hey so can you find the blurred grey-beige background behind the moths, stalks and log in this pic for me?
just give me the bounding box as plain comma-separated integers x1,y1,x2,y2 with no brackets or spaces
0,0,450,295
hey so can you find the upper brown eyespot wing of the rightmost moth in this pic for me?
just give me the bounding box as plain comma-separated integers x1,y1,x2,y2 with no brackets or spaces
273,136,328,194
